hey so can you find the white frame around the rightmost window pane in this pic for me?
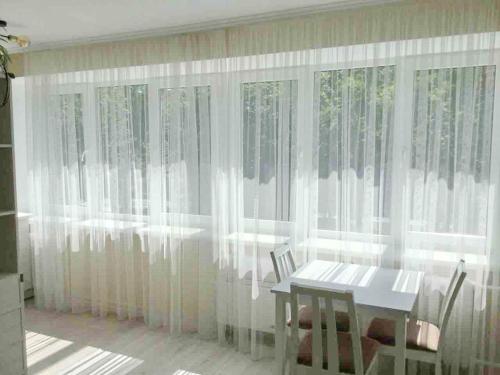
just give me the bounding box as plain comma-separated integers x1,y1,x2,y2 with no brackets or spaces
391,50,500,255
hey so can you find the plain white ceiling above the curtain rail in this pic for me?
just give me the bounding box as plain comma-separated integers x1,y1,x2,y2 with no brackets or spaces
0,0,380,49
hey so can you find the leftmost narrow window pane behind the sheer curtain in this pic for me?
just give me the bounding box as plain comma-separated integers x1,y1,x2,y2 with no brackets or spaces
50,94,87,204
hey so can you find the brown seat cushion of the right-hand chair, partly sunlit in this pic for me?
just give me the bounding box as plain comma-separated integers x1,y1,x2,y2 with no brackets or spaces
367,319,439,352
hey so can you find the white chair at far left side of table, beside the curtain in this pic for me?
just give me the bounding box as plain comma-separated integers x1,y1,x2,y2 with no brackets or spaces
271,248,349,332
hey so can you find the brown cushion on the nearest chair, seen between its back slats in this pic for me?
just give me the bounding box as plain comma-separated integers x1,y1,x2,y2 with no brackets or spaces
297,331,380,374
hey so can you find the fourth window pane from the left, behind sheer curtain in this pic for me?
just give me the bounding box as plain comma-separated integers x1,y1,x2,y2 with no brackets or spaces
241,80,298,221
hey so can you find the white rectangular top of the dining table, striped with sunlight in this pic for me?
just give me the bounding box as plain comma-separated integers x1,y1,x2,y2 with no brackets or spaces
271,260,424,313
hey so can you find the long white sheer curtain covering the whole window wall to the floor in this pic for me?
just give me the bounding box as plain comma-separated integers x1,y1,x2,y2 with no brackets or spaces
22,1,500,374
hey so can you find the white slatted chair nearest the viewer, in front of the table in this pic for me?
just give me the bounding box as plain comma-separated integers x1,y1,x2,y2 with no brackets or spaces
287,283,380,375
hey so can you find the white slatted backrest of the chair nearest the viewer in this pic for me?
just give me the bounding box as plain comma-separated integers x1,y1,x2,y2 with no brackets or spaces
289,282,364,375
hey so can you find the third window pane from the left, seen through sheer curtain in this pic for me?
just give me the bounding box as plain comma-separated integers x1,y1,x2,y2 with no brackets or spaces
159,86,211,215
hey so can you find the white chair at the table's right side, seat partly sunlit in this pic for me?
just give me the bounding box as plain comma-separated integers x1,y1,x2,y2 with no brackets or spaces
367,260,467,375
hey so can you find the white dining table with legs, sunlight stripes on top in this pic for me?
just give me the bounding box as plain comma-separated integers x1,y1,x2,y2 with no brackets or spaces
271,260,423,375
